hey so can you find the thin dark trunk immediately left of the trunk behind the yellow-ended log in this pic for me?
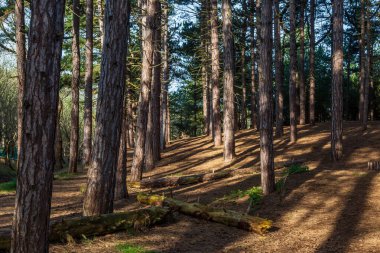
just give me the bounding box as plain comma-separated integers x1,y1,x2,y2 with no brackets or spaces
249,0,257,129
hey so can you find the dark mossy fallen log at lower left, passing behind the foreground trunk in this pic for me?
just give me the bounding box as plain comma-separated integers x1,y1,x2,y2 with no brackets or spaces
0,207,170,252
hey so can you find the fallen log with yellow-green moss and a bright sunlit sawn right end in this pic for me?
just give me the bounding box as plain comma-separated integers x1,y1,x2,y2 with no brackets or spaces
137,193,272,235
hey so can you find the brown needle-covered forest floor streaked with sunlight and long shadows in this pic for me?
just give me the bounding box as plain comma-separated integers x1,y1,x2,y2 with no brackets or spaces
0,122,380,253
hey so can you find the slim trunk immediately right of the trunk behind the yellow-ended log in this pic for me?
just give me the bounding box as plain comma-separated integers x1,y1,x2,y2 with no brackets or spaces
274,0,284,137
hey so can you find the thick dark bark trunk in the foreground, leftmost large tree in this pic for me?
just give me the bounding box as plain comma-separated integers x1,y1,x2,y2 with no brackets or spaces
11,0,65,253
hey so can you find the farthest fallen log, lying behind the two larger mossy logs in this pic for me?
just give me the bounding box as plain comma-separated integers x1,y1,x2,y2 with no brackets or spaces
129,171,232,189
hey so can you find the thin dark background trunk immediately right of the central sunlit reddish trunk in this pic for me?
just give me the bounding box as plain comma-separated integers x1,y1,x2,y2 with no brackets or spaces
241,0,248,129
